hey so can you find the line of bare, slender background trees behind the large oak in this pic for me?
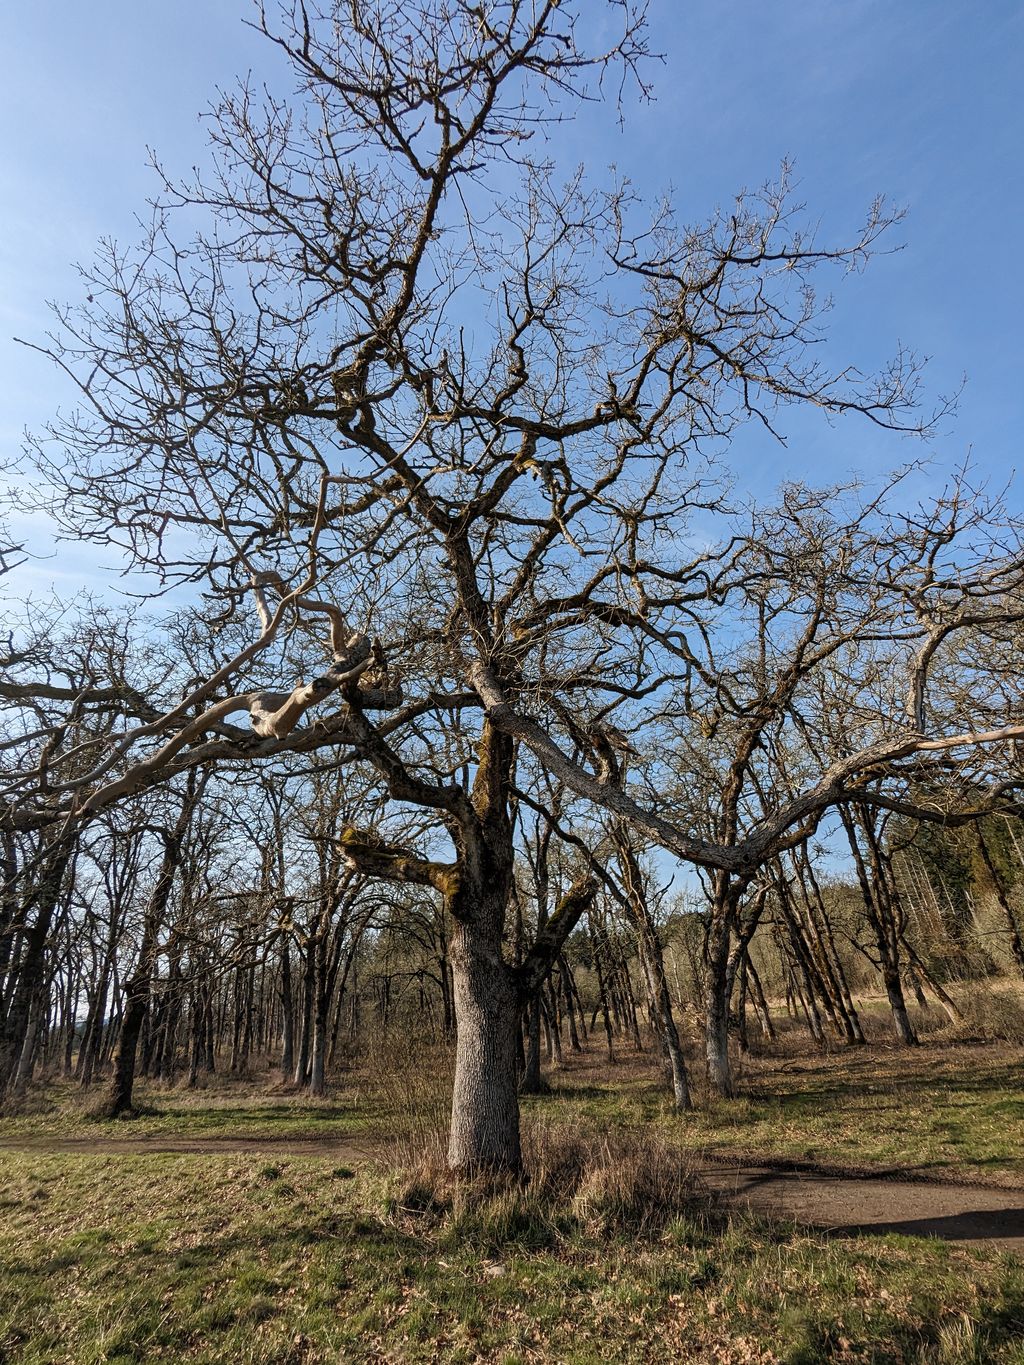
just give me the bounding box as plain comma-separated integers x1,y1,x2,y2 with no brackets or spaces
0,704,1024,1117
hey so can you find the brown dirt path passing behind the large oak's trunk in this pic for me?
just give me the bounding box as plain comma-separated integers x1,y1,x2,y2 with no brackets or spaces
0,1137,1024,1254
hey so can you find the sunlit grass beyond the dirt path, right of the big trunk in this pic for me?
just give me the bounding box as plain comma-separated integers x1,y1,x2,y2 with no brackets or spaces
530,1044,1024,1183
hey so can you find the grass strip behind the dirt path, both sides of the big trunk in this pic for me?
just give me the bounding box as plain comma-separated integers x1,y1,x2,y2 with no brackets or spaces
8,1035,1024,1185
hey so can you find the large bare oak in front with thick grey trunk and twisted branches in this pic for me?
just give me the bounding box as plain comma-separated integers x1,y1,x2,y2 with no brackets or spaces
5,0,1024,1170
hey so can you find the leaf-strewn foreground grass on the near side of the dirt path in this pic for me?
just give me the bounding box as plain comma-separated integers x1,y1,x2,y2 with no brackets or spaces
0,1152,1024,1365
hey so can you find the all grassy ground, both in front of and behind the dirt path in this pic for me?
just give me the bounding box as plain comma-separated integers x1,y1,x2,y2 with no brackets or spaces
0,1037,1024,1365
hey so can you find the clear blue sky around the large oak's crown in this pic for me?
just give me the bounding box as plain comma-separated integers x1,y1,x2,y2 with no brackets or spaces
0,0,1024,592
